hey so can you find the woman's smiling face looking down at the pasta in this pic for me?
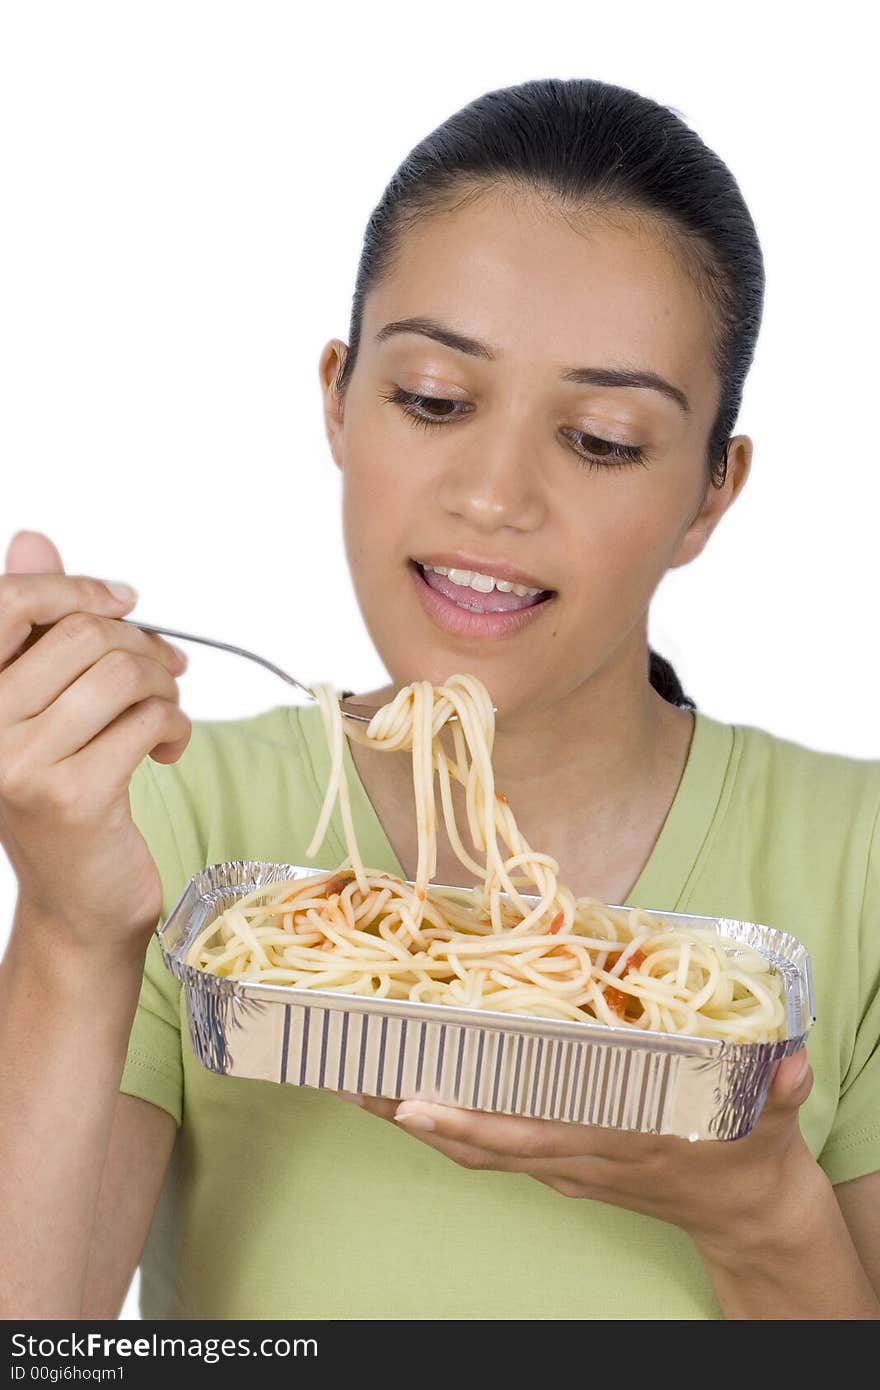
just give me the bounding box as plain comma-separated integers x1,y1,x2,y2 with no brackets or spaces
321,192,751,714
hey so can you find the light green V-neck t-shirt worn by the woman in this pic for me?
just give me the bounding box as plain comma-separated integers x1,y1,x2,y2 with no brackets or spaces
121,706,880,1319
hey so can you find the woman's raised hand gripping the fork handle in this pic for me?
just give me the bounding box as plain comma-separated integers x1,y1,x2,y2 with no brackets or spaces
0,531,192,955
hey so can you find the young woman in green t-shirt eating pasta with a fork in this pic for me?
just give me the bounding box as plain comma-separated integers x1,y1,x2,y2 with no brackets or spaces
0,81,880,1319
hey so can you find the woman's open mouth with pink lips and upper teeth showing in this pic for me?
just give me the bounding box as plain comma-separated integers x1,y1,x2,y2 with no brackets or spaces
409,560,556,637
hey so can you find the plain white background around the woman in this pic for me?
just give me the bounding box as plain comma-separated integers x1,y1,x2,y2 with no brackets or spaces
0,0,880,1316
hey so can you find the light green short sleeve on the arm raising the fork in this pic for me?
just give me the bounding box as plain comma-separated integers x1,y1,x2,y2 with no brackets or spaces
120,758,194,1125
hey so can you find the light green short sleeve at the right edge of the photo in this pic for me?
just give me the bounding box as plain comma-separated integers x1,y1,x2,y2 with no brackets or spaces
819,812,880,1183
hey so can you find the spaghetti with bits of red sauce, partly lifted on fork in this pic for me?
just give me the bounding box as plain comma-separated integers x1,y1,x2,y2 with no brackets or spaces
186,676,785,1043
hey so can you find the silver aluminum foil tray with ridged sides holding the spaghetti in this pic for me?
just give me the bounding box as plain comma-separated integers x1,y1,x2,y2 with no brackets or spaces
157,859,813,1140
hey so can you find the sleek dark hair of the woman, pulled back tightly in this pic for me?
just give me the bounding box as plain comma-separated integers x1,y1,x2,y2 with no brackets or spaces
335,78,765,709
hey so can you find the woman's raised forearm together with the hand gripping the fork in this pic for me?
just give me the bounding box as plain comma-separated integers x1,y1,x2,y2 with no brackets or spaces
0,532,192,1319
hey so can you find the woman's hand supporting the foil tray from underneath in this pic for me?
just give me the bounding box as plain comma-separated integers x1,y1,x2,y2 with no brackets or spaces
337,1051,827,1254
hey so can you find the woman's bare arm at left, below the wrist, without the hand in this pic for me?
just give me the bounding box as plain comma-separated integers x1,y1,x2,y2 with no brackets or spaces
0,908,175,1319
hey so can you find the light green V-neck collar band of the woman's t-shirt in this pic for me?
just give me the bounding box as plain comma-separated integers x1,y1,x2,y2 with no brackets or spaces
289,705,741,912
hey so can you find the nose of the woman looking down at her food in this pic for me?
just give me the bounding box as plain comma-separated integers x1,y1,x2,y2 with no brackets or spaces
437,435,546,531
